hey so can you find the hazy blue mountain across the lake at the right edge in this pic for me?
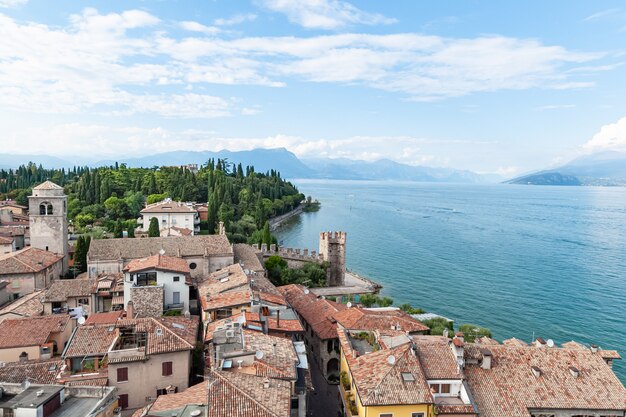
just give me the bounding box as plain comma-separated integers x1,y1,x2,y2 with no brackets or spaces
507,152,626,186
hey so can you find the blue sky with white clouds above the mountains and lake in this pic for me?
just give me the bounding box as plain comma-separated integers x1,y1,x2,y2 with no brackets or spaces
0,0,626,176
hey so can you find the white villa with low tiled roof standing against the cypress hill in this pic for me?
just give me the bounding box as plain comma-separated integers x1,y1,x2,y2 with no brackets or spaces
140,198,200,234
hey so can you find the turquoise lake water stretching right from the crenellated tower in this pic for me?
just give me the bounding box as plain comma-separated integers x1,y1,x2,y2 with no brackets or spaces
276,181,626,381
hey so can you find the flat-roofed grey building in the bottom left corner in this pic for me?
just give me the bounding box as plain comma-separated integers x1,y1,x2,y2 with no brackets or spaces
0,384,118,417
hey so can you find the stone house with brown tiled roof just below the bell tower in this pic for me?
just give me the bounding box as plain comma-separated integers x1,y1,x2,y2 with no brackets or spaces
0,246,63,298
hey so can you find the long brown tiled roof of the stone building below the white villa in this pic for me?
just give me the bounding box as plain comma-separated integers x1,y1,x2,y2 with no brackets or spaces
88,235,233,262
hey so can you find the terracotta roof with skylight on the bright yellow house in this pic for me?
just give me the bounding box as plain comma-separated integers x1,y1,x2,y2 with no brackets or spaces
338,330,434,406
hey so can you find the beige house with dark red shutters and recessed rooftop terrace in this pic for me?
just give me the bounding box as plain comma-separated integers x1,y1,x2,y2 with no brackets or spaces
107,312,199,409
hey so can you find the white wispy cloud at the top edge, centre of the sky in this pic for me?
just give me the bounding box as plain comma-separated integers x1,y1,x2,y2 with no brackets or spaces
261,0,396,29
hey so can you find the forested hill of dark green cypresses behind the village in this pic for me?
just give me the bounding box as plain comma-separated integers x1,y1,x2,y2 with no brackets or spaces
0,159,304,242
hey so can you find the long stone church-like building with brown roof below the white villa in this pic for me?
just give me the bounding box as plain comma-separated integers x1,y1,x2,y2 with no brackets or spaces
87,235,234,278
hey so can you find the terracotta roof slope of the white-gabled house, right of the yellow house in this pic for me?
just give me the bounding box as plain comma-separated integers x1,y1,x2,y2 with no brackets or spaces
413,336,463,379
